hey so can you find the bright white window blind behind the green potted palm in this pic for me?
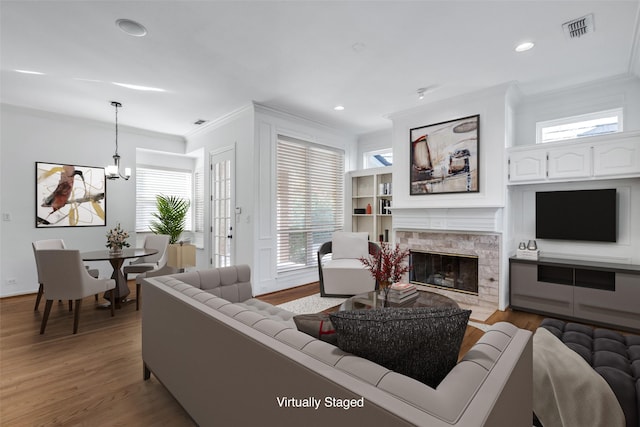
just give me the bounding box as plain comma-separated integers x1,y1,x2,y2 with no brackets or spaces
136,167,193,232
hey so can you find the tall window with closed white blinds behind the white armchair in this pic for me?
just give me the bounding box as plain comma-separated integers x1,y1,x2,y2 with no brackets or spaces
276,135,344,272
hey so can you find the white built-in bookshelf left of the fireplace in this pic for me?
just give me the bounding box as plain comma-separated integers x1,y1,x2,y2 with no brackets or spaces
346,167,393,242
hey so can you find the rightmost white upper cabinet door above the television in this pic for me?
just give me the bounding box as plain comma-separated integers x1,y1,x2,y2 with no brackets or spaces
593,138,640,176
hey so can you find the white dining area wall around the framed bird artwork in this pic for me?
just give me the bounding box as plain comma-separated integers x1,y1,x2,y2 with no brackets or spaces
0,104,184,297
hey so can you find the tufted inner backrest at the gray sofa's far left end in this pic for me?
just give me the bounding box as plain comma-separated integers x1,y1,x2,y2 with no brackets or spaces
172,265,253,303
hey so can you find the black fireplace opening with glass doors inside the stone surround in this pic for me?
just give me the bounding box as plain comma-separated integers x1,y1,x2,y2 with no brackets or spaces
409,250,478,295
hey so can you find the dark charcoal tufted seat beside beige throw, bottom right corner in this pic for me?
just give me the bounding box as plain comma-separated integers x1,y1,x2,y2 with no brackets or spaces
540,319,640,427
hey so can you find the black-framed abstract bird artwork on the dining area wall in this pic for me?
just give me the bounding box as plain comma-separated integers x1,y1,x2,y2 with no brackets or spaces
36,162,107,228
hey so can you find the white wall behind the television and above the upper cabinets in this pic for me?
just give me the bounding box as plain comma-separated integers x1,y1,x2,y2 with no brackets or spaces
507,76,640,264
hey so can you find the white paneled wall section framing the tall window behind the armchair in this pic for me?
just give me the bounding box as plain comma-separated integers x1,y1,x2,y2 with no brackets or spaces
253,105,357,295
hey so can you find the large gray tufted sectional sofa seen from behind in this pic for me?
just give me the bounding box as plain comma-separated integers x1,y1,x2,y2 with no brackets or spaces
142,266,532,427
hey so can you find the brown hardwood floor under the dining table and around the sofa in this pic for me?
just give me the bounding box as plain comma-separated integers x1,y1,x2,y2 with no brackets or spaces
0,281,542,426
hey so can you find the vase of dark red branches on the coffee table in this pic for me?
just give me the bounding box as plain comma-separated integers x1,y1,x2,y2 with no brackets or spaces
360,242,410,307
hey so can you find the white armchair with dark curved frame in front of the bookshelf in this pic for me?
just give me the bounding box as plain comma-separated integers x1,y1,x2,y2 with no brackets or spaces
318,231,380,297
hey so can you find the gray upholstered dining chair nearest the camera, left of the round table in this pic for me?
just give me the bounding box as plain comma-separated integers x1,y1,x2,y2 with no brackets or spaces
36,249,116,334
